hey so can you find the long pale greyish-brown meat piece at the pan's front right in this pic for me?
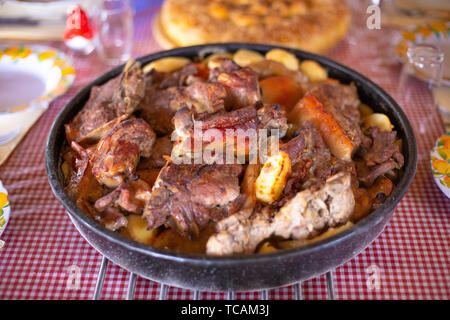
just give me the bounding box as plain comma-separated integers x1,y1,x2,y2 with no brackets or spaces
206,173,355,255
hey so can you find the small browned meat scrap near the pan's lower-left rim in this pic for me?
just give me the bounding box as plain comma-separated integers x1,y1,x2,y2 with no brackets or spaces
94,179,151,213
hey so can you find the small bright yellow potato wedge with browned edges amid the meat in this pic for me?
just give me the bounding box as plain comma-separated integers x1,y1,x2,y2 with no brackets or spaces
255,151,292,204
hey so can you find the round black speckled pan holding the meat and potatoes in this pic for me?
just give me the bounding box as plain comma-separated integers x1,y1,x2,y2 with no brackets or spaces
45,43,417,291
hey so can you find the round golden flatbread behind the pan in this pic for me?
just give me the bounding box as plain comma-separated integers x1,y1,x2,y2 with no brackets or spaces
159,0,351,53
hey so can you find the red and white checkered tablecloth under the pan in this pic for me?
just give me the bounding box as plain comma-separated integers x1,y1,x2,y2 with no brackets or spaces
0,3,450,299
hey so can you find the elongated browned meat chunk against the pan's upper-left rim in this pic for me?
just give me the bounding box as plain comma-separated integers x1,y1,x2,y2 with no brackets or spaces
65,60,145,143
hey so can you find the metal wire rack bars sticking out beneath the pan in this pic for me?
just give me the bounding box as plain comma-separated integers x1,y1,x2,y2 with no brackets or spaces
93,257,334,300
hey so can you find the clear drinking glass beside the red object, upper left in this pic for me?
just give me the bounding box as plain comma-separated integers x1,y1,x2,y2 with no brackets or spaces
96,0,133,65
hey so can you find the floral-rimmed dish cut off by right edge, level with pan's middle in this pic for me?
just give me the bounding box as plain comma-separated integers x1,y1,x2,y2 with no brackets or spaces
430,132,450,198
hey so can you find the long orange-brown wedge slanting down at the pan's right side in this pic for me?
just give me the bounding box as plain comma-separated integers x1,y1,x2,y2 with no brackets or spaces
288,93,355,161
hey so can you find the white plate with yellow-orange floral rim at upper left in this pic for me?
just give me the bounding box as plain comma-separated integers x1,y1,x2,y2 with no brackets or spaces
0,46,75,116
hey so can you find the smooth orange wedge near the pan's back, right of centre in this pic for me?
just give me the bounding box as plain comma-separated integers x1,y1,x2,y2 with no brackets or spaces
259,76,303,112
